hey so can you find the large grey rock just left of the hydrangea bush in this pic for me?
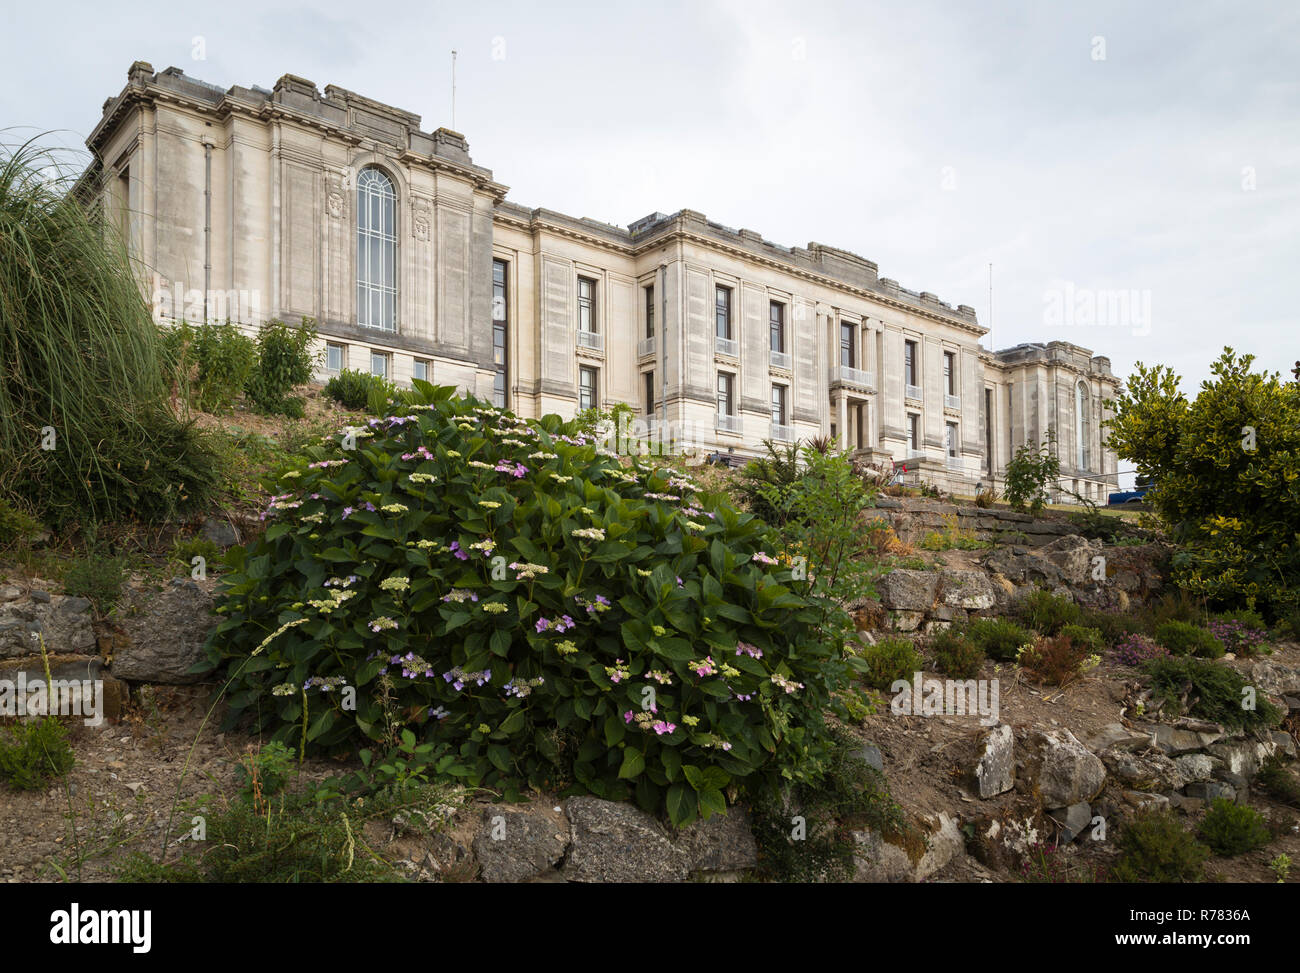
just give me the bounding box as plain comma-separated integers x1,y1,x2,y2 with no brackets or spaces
113,579,217,686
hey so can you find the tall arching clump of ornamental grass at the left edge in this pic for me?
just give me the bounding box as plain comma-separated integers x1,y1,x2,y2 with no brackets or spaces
0,142,216,528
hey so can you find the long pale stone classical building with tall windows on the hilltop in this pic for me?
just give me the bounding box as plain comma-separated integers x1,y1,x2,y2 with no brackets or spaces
82,61,1117,498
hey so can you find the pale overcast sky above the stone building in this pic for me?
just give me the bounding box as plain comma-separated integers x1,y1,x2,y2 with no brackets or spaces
0,0,1300,403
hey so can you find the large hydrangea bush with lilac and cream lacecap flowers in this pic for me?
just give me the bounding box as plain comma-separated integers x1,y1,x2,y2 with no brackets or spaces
208,382,846,826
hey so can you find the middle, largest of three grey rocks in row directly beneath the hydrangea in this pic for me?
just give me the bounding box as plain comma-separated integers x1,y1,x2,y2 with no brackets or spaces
562,797,690,882
